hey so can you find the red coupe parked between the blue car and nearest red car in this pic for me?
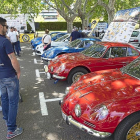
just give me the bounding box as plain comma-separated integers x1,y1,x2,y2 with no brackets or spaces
46,42,140,84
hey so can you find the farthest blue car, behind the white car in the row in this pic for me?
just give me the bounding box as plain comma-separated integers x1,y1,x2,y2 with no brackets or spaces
31,32,67,49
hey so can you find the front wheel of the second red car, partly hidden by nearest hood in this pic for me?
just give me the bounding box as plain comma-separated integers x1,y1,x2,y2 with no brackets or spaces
67,67,88,84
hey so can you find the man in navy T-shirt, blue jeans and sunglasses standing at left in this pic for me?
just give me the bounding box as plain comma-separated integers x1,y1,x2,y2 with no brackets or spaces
0,17,23,139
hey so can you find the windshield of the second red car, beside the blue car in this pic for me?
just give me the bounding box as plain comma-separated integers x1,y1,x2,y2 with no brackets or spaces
81,44,106,58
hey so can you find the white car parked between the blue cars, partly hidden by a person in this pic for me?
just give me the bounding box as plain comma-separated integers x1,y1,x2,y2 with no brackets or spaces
35,34,70,55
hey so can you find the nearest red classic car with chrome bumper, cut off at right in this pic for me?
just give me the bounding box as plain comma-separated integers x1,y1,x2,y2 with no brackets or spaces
61,57,140,140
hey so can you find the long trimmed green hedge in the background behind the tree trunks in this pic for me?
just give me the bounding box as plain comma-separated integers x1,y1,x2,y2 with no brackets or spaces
27,22,82,31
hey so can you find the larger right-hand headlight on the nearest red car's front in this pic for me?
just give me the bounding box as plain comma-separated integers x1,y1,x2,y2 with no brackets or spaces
91,105,108,121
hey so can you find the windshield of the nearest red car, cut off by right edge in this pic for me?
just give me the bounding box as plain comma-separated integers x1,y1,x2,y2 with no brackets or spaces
120,57,140,80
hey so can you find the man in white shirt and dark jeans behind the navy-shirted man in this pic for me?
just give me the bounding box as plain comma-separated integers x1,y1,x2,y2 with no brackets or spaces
7,27,20,56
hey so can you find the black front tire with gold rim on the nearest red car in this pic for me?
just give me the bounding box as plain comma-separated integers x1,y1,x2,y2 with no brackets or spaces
114,112,140,140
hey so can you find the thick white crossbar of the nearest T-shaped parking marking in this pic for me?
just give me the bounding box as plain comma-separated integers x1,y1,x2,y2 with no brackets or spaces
39,92,48,116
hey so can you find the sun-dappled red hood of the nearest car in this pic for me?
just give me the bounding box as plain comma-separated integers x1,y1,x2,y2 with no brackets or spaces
64,70,140,112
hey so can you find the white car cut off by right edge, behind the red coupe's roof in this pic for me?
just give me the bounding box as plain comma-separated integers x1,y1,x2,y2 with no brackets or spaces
129,29,140,48
